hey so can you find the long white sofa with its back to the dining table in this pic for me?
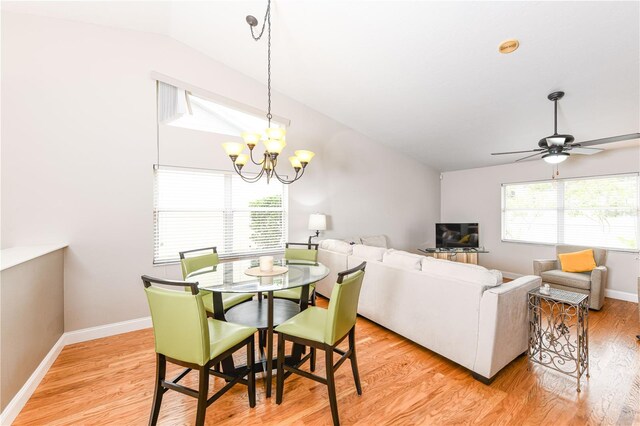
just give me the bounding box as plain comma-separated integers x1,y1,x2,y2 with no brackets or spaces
316,240,541,383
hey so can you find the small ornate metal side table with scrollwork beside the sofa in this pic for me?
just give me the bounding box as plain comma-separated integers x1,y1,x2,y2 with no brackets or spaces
528,288,589,392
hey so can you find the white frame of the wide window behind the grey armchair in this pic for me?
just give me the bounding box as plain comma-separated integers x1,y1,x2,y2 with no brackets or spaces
500,172,640,253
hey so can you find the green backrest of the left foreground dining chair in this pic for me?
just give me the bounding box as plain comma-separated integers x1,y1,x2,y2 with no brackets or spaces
142,275,210,365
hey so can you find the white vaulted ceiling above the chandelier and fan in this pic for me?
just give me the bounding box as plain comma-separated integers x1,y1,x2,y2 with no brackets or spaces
2,0,640,170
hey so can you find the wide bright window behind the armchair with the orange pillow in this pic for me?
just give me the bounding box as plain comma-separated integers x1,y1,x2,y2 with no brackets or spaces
502,174,639,250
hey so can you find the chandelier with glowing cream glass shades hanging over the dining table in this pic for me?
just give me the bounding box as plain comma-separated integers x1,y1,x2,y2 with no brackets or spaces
222,0,315,184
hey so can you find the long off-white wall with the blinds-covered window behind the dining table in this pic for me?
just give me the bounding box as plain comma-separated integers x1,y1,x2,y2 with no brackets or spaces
1,13,440,331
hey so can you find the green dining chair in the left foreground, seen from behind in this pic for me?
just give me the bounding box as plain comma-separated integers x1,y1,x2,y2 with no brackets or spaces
142,275,257,425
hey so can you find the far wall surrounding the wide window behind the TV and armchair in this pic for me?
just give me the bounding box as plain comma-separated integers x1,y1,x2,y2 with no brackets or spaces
441,145,640,297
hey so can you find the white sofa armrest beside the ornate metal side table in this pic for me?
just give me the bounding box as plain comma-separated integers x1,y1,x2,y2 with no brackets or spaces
473,275,542,379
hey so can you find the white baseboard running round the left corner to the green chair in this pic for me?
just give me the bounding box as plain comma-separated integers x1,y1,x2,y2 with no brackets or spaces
0,317,151,425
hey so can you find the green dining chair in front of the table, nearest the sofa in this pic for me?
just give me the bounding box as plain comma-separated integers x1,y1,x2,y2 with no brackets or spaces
275,262,367,425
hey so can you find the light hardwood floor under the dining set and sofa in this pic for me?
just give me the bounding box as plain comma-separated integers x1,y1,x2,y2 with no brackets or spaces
14,299,640,425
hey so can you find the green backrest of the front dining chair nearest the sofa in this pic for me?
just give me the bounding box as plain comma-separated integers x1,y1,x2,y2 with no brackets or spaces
324,262,367,345
